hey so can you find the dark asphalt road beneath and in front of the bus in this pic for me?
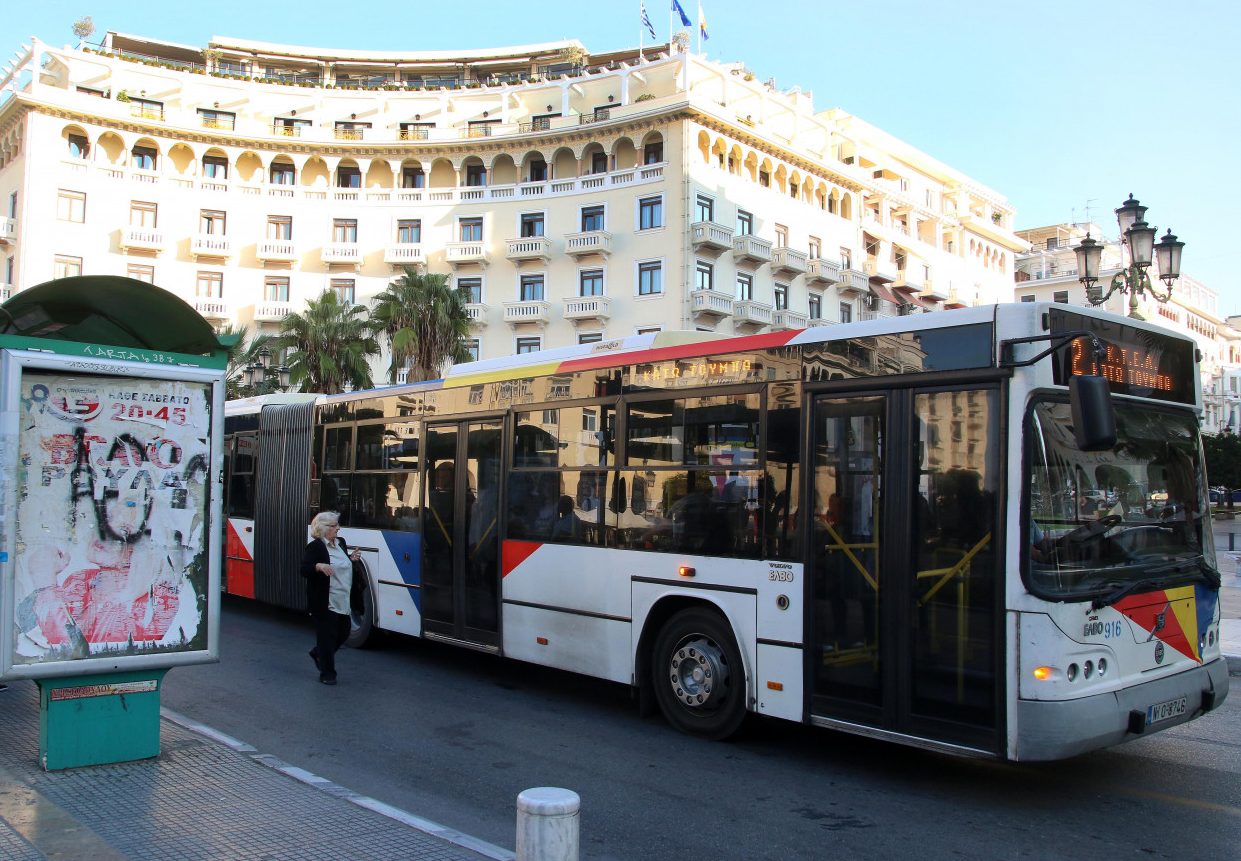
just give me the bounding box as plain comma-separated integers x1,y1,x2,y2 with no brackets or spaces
164,602,1241,861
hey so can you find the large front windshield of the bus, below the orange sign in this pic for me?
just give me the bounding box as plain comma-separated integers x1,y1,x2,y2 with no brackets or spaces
1025,401,1219,605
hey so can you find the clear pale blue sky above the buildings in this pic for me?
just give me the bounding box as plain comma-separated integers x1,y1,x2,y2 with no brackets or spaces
9,0,1241,314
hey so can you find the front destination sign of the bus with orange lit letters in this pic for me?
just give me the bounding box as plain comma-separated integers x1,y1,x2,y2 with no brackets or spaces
1051,309,1195,403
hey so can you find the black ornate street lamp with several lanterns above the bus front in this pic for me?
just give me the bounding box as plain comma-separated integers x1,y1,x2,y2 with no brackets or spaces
1073,195,1185,320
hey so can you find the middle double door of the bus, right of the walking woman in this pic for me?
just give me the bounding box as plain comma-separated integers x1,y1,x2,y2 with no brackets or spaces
422,421,503,648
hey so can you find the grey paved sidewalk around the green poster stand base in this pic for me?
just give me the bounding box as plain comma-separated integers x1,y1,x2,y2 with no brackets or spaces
0,681,514,861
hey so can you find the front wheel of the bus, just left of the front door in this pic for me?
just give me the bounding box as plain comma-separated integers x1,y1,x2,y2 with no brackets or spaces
650,608,746,741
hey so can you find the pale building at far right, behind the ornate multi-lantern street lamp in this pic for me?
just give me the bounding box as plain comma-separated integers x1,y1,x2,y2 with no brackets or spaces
1015,223,1241,433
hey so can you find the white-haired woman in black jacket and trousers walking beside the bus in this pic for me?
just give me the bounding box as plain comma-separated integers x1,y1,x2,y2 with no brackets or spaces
302,511,360,685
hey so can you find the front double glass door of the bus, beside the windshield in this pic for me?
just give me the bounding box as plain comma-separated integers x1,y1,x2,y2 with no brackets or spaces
802,387,1003,751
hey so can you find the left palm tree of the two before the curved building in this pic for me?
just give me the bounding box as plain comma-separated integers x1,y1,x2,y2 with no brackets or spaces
274,289,380,395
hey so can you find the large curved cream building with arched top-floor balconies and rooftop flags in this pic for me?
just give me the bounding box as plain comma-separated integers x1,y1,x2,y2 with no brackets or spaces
0,32,1025,374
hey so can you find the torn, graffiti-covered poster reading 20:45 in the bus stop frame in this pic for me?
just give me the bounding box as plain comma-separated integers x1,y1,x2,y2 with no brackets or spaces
14,372,211,664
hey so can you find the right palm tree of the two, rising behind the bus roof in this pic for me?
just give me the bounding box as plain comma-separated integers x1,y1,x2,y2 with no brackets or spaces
371,267,470,382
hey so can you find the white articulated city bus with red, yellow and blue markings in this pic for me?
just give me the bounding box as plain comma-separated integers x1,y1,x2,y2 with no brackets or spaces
226,304,1229,761
